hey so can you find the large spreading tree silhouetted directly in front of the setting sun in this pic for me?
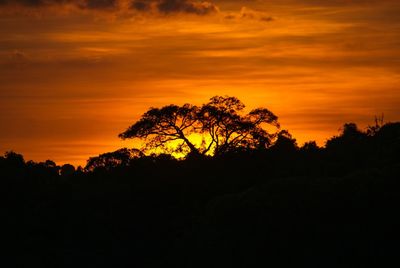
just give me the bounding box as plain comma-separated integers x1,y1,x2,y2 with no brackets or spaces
119,96,279,155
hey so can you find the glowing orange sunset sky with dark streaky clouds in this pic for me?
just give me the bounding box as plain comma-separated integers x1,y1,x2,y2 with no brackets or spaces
0,0,400,165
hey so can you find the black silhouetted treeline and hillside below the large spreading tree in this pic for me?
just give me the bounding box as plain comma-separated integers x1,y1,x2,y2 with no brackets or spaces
0,123,400,267
